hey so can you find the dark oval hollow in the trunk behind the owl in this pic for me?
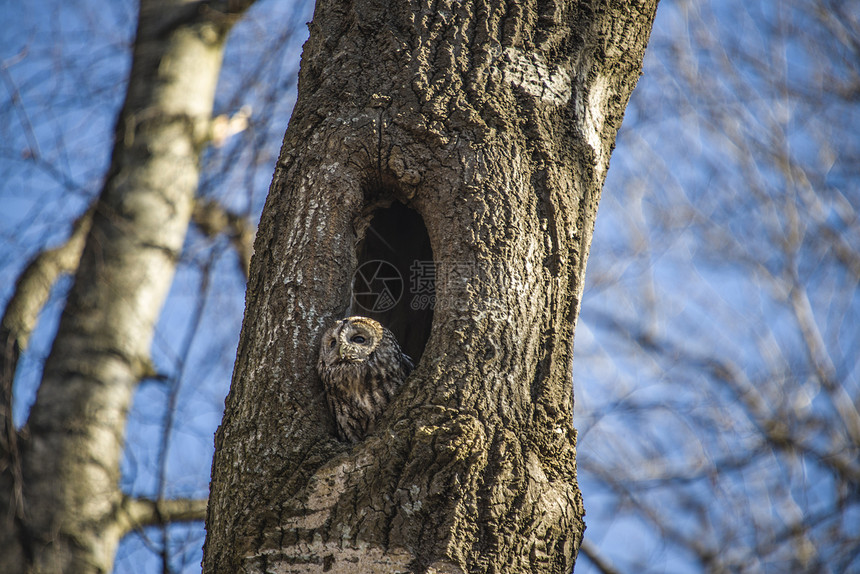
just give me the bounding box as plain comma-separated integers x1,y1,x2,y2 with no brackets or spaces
350,201,436,365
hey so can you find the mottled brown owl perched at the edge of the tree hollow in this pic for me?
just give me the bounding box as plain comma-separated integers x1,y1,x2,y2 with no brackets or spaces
317,317,414,442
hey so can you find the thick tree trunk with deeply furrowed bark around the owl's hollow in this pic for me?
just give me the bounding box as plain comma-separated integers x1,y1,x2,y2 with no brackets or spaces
204,0,656,574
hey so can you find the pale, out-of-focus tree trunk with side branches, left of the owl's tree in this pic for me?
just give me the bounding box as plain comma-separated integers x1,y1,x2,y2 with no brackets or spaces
0,0,251,573
